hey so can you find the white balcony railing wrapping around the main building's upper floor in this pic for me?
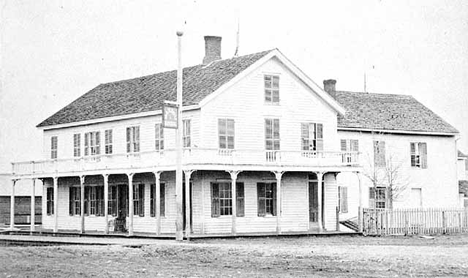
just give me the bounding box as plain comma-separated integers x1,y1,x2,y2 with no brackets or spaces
12,148,359,176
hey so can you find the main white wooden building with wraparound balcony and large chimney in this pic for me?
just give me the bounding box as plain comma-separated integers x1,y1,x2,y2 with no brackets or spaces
9,37,456,236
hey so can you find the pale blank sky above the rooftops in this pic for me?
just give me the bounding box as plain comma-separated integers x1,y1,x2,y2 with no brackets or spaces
0,0,468,173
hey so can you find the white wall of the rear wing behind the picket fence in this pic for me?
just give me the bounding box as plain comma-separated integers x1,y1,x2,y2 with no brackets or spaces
338,131,459,222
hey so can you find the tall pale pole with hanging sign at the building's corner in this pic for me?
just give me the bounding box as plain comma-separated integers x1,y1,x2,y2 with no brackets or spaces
175,31,184,241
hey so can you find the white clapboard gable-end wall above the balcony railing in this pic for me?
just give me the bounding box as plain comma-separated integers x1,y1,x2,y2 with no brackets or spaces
201,56,338,151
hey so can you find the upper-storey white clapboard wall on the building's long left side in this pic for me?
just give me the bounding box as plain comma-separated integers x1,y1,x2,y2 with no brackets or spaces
43,110,200,159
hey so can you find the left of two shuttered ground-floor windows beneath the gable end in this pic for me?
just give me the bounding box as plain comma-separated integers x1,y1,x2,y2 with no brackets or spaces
211,182,244,217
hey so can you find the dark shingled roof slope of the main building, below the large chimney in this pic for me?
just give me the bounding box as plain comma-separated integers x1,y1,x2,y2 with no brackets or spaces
38,50,272,127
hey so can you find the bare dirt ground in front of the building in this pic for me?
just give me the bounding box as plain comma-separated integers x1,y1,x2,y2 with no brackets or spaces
0,235,468,277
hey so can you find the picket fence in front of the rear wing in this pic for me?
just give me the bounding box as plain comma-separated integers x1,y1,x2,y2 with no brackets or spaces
362,208,468,235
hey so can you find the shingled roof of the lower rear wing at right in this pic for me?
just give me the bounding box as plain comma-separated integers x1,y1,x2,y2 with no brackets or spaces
336,91,458,134
